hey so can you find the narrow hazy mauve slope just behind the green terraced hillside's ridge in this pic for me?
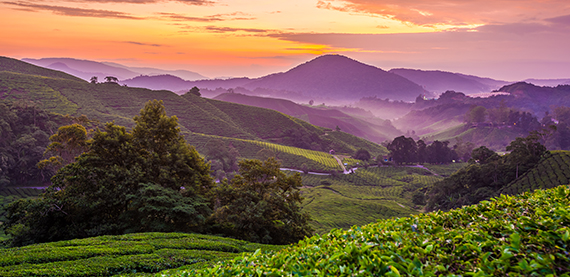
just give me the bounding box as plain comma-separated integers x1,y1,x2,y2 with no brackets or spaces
214,93,401,142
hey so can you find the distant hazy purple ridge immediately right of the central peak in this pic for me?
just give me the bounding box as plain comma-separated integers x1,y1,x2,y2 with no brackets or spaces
389,68,509,95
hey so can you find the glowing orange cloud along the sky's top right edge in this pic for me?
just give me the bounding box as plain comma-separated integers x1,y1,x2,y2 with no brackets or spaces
317,0,570,26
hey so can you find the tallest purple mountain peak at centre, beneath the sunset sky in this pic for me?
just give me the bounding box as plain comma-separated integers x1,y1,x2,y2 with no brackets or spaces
245,55,426,101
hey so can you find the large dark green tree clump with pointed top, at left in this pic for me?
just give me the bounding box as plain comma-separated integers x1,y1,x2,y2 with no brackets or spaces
3,100,212,245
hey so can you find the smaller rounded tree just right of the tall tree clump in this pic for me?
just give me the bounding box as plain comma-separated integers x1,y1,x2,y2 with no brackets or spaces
213,158,312,244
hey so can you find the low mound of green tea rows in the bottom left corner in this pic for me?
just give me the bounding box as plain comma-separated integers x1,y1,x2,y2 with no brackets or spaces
0,233,280,276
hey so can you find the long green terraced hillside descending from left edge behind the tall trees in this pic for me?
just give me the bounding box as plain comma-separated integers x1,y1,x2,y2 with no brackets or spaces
0,58,385,168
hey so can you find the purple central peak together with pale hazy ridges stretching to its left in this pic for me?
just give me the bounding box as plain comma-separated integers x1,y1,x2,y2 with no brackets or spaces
50,55,432,101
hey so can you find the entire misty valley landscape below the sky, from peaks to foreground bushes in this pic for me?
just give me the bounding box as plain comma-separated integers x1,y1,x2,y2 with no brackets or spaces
0,55,570,276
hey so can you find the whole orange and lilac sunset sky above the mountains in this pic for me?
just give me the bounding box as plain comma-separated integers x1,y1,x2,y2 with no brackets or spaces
0,0,570,81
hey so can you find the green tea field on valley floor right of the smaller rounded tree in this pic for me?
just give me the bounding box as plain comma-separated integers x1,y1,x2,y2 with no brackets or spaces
301,166,443,233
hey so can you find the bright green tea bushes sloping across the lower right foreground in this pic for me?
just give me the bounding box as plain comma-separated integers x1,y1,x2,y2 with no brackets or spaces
184,186,570,276
